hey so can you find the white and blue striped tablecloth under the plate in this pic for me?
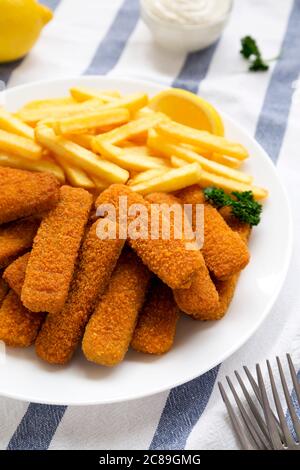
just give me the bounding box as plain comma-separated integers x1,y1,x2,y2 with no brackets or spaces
0,0,300,449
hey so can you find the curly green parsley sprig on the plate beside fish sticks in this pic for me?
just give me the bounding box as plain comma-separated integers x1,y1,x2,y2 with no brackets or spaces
204,188,262,226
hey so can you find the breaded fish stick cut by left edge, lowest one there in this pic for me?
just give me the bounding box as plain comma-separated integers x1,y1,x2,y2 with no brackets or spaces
0,290,45,347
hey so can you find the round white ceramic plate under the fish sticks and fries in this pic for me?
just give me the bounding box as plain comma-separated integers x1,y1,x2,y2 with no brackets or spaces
0,77,292,405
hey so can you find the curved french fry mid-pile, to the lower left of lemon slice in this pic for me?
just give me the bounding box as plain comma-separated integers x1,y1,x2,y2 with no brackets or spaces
95,142,170,171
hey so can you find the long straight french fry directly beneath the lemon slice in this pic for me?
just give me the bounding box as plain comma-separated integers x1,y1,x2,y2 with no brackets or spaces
156,121,248,160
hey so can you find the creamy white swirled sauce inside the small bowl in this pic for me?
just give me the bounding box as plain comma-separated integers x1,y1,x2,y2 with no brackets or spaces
143,0,232,25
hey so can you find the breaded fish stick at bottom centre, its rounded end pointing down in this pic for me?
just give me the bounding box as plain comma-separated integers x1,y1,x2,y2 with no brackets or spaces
82,249,150,366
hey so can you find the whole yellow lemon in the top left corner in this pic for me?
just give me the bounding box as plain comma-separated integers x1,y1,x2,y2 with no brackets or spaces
0,0,53,62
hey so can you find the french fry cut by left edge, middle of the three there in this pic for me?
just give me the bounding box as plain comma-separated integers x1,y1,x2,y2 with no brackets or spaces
0,129,42,160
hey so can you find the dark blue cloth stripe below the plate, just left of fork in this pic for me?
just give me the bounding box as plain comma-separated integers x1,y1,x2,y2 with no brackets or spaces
150,366,220,450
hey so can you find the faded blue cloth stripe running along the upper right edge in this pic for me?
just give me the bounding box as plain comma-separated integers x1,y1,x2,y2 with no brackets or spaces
255,0,300,162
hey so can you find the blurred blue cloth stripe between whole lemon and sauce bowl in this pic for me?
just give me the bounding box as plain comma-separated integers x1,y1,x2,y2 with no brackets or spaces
84,0,139,75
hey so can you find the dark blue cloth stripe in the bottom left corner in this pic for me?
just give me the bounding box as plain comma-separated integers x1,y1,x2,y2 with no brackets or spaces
7,403,67,450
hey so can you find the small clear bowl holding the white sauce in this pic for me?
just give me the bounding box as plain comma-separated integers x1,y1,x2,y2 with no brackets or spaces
140,0,232,53
